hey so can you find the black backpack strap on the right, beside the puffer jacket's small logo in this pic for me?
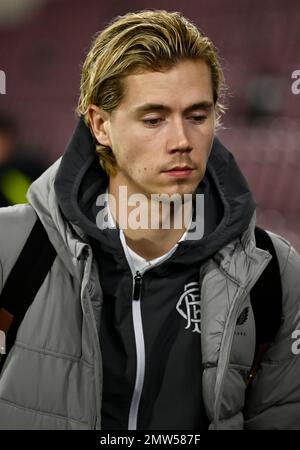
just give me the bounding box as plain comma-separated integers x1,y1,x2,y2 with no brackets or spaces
248,227,282,386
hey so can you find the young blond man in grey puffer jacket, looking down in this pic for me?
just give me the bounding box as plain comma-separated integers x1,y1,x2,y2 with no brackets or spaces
0,11,300,430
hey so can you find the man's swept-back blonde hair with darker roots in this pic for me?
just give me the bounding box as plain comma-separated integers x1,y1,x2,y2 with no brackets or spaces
76,10,224,175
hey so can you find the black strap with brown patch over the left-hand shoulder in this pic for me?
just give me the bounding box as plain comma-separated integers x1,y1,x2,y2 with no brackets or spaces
0,218,56,370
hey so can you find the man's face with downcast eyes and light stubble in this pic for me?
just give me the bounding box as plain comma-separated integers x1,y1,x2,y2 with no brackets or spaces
96,60,215,195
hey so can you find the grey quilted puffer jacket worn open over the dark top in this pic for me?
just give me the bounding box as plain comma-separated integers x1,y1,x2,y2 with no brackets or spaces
0,136,300,429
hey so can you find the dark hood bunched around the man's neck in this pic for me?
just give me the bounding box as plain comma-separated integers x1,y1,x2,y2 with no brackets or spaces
28,118,255,270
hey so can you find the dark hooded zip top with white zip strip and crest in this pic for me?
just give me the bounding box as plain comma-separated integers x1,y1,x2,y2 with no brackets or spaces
55,119,255,431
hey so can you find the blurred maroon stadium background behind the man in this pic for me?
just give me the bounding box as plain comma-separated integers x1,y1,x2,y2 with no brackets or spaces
0,0,300,251
